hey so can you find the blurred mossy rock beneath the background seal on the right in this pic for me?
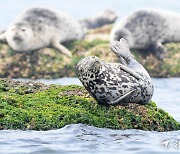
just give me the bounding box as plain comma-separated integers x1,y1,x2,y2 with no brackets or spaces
133,43,180,77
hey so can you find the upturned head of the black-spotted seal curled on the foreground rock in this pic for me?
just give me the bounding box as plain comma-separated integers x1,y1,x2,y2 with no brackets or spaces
76,56,103,87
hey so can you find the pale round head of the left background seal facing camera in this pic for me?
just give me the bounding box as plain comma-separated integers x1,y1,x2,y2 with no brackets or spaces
6,23,33,52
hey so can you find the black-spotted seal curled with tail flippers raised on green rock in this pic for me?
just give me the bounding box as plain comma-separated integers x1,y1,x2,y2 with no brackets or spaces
77,38,154,105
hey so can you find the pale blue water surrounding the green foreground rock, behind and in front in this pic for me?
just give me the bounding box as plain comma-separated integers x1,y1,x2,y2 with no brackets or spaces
0,78,180,154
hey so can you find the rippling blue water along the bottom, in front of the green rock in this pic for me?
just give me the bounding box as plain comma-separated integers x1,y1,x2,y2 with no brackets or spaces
0,124,180,154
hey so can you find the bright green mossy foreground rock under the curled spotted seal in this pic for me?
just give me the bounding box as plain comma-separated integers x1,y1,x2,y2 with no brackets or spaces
0,79,180,131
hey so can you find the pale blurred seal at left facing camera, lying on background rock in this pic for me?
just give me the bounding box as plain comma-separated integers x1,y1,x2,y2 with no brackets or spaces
0,8,85,56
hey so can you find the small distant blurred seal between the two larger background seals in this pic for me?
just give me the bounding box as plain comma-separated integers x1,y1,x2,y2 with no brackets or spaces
80,10,117,29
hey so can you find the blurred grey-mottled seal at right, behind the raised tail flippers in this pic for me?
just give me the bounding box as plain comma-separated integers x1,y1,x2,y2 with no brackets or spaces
110,9,180,60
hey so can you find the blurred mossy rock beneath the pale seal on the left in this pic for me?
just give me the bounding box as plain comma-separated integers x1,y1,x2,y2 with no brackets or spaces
0,40,107,79
